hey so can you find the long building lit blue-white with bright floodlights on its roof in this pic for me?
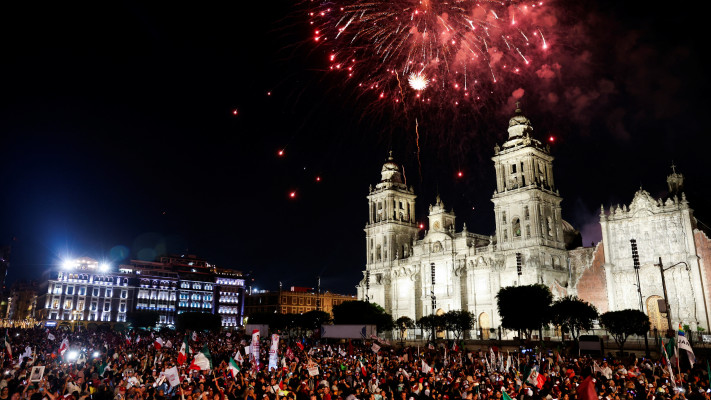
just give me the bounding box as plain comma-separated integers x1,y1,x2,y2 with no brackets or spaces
37,256,244,328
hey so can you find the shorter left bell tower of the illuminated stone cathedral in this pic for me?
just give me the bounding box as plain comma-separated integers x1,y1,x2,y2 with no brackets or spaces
365,152,418,270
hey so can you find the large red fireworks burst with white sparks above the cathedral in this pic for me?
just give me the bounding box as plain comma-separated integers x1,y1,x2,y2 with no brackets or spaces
308,0,555,112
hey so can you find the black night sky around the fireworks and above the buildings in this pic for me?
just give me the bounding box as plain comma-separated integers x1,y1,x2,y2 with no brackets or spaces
0,0,711,293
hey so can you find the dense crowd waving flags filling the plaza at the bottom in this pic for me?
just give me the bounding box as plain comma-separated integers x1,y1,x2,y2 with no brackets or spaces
0,328,711,400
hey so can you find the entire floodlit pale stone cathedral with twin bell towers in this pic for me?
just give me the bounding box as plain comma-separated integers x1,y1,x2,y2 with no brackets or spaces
357,109,711,336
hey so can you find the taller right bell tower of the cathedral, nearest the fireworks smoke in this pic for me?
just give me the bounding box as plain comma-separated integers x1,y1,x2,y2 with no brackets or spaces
491,108,565,250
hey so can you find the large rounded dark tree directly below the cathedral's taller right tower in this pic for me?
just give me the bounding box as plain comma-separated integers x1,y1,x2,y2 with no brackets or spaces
496,283,553,338
